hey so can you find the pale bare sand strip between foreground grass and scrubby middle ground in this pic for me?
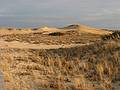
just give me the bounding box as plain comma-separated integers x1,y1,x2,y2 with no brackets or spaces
0,40,89,49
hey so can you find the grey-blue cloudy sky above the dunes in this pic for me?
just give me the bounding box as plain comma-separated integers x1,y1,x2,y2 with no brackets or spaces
0,0,120,28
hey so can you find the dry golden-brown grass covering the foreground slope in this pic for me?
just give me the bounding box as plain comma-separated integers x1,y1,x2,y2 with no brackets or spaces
0,41,120,90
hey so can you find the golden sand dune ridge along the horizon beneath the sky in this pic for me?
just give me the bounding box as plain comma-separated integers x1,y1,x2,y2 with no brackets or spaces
0,24,112,35
